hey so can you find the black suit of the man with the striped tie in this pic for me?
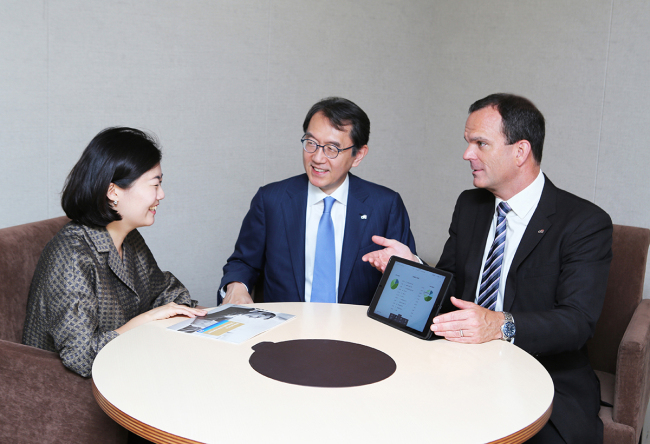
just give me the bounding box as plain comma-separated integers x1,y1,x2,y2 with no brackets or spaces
437,178,612,443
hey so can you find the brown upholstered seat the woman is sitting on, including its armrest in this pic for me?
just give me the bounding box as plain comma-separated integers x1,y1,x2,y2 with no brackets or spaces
0,217,127,444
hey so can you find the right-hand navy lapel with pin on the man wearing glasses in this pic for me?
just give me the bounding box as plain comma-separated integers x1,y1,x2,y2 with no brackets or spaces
338,174,372,302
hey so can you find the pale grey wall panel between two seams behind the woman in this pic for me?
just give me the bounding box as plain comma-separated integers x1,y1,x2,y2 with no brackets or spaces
41,1,268,305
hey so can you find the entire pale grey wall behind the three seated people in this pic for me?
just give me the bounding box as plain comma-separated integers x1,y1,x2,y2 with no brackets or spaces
0,0,650,305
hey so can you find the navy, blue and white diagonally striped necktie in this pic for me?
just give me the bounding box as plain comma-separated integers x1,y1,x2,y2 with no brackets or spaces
476,202,511,310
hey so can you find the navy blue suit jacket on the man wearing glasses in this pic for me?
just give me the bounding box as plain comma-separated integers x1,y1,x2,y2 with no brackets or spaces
218,174,415,305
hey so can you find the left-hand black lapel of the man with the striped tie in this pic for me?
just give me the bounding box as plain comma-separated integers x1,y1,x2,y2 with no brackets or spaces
461,193,494,302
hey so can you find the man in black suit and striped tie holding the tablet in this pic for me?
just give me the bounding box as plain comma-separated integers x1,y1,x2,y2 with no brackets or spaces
364,94,612,443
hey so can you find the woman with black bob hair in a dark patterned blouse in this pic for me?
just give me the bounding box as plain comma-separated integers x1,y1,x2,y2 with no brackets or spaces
23,127,206,377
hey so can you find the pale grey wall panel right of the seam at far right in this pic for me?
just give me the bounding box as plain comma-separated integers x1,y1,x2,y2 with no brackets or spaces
594,0,650,297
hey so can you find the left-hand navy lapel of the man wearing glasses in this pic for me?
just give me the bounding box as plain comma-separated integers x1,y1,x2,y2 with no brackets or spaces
281,175,307,302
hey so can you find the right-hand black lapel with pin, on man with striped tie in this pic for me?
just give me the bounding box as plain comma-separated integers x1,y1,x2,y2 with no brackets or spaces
503,175,557,311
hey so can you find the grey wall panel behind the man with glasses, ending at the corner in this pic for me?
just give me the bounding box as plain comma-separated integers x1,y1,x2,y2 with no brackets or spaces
266,1,434,266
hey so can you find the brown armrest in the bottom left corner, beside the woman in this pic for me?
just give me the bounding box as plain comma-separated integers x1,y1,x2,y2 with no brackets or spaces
0,340,127,444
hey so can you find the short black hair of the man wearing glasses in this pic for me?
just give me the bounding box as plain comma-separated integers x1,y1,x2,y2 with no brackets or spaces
302,97,370,157
